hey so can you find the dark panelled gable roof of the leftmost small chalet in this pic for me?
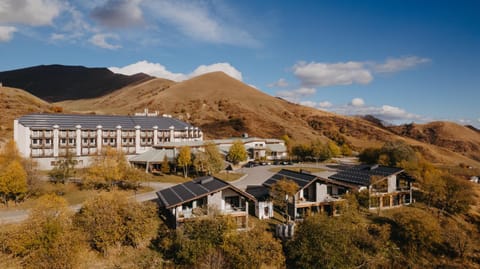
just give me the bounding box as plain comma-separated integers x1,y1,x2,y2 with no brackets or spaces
157,176,255,208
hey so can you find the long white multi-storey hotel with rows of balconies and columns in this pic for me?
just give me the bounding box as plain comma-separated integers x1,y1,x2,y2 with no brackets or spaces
14,114,203,170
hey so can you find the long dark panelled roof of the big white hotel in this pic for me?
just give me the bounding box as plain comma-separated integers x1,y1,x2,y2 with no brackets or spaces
18,113,192,130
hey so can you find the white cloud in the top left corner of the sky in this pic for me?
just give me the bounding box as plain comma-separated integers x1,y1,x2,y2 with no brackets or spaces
0,0,62,26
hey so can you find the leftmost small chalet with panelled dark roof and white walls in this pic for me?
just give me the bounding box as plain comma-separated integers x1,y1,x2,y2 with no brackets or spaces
157,176,255,229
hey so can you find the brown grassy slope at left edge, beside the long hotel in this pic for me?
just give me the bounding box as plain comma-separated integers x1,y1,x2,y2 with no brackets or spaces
0,87,53,146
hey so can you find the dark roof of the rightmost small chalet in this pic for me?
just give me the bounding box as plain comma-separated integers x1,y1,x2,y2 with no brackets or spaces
328,165,403,186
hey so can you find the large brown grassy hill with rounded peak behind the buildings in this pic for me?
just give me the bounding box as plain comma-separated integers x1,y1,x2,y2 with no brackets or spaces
58,72,478,165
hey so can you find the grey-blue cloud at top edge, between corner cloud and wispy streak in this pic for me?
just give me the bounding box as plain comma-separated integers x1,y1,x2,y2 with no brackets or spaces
91,0,143,27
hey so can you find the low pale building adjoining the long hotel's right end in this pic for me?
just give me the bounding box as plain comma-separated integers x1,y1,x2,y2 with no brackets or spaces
129,137,288,173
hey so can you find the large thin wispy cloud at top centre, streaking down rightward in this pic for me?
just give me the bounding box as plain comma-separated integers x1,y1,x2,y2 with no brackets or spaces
145,0,258,46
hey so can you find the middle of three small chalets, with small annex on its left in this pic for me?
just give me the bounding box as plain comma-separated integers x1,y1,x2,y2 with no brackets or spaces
246,169,354,220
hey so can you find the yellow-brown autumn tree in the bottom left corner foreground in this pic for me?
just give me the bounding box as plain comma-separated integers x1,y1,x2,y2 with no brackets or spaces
7,194,82,269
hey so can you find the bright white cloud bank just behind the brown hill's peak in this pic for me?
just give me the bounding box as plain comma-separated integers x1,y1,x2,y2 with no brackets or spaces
109,61,242,81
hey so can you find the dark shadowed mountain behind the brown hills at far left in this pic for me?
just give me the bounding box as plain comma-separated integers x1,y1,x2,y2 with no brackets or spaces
0,65,151,101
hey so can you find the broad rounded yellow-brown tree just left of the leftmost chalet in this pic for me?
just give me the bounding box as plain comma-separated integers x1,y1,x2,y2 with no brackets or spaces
75,192,159,255
